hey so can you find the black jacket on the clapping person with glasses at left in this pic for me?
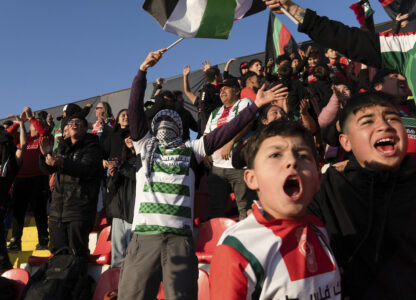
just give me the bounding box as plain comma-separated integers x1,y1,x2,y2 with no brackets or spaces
40,133,102,222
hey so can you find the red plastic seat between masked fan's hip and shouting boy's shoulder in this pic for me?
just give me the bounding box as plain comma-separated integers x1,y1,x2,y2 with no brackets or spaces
195,218,237,263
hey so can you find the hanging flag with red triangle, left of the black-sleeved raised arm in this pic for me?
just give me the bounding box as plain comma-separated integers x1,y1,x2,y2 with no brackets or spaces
265,12,298,72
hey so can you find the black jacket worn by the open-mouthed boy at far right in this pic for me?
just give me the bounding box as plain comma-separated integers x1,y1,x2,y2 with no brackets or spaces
309,156,416,299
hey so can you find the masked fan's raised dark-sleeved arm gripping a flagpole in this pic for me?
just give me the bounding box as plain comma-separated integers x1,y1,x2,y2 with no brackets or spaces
128,49,166,141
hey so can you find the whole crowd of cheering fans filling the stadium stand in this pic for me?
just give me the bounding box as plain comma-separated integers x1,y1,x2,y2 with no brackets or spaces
0,0,416,299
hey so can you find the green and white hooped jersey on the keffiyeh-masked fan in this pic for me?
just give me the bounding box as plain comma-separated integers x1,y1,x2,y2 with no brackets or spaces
132,133,205,235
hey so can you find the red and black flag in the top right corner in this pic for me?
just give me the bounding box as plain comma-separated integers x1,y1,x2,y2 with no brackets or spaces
378,0,416,32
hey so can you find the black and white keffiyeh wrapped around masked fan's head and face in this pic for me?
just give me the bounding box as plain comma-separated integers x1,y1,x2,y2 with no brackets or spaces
145,109,183,180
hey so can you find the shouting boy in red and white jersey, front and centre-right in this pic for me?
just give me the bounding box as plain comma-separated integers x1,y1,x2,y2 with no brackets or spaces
210,120,341,300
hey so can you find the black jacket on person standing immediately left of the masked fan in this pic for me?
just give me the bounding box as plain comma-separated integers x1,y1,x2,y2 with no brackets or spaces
106,157,137,224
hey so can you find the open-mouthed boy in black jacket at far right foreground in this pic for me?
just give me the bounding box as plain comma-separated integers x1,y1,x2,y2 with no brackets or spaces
309,92,416,299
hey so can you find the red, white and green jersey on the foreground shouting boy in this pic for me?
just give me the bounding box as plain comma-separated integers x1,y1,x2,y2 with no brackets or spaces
210,202,341,300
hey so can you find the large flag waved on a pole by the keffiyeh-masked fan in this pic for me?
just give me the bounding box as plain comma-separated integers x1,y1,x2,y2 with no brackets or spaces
143,0,266,39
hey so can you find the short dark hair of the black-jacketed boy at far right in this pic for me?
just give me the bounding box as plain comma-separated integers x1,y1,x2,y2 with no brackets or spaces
339,91,397,132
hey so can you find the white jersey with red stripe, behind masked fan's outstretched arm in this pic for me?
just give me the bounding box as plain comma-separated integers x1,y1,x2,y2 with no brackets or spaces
204,98,253,169
